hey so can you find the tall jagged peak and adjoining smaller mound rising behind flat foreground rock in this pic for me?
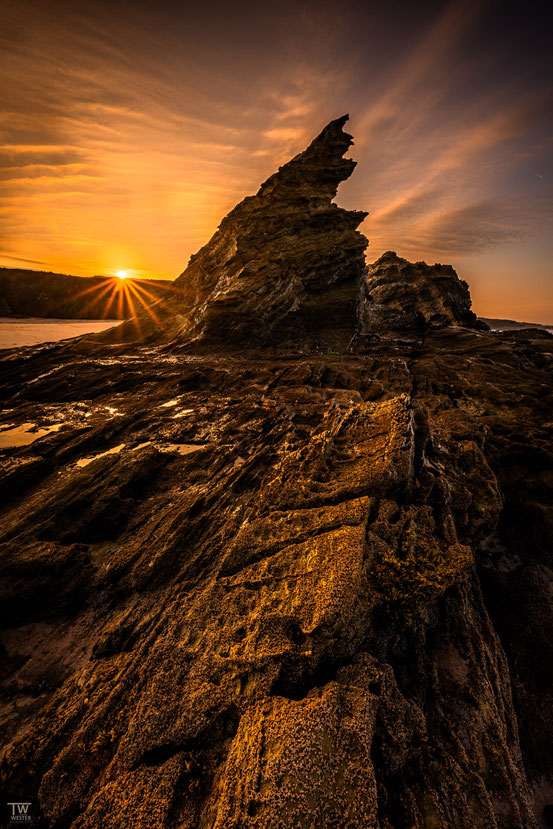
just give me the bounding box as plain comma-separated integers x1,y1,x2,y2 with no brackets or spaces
105,115,485,350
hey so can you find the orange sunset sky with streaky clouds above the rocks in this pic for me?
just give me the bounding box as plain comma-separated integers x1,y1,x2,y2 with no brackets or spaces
0,0,553,323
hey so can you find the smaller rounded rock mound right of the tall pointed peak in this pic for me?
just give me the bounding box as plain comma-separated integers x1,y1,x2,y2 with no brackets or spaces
361,251,480,337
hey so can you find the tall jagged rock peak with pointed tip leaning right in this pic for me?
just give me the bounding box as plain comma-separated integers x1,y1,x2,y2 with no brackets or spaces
167,115,368,345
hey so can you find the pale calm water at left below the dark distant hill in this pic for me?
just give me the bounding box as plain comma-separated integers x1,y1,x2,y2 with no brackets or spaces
0,317,120,348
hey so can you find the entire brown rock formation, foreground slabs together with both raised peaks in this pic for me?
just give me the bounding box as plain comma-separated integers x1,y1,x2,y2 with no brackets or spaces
0,119,553,829
